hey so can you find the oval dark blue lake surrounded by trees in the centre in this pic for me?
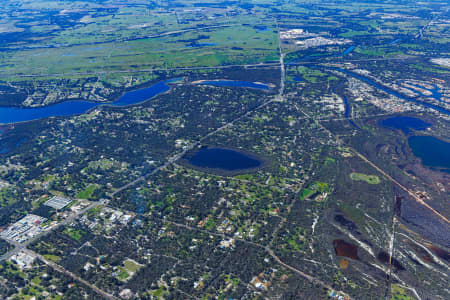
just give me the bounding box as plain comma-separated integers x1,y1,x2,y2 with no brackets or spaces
187,147,262,171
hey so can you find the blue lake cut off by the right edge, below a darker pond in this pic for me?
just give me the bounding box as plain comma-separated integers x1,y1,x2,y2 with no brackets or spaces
408,136,450,172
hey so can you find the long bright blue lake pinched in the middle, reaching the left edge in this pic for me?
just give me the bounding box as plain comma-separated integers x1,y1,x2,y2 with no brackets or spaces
0,78,178,124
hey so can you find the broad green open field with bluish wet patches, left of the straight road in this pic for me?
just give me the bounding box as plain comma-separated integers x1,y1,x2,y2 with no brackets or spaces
0,20,278,77
